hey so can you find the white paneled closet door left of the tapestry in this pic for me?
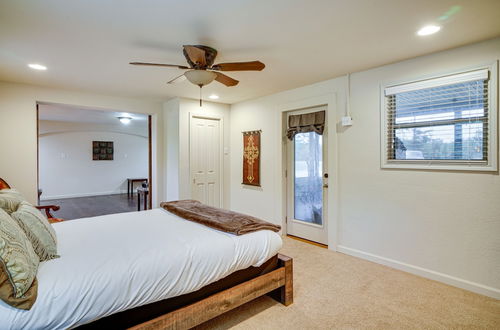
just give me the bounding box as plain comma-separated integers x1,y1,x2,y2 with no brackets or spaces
190,116,222,207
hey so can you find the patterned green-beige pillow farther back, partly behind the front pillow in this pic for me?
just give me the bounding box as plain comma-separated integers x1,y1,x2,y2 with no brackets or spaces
11,202,59,261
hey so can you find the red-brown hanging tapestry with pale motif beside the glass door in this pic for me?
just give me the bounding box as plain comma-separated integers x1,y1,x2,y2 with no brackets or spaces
243,130,261,186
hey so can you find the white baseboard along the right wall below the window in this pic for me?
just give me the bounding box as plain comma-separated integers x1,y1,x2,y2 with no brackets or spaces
337,245,500,299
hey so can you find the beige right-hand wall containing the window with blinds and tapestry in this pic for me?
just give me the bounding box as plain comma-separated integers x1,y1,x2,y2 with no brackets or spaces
231,39,500,298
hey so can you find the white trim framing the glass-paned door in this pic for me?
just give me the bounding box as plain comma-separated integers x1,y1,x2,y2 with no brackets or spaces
275,93,339,251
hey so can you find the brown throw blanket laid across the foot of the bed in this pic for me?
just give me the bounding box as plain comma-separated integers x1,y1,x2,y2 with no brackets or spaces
160,199,281,235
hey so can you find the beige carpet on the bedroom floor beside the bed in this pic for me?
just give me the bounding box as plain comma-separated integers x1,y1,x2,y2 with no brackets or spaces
197,238,500,329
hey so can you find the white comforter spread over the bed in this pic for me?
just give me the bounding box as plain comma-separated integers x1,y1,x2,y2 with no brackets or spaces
0,209,282,329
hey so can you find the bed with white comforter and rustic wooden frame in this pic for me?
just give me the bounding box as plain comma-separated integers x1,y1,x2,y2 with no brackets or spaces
0,209,292,329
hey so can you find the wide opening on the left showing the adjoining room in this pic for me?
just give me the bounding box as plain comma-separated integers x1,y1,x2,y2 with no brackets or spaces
37,103,152,220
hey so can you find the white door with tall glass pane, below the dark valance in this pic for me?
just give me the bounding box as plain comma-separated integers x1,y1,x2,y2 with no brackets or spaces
286,109,328,244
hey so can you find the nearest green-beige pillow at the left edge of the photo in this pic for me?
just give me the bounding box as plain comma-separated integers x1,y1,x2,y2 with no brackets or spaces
0,209,39,309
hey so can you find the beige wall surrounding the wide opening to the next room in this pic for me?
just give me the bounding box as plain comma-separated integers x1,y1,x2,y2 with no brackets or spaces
0,82,163,203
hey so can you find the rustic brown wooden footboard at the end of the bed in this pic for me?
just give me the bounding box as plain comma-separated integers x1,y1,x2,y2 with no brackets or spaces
130,254,293,330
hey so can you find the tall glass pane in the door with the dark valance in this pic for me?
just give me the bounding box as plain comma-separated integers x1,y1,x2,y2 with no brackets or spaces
294,132,323,225
